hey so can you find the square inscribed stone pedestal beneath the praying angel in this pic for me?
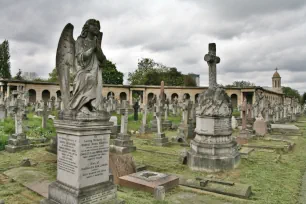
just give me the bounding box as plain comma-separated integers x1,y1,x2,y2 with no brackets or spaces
41,120,118,204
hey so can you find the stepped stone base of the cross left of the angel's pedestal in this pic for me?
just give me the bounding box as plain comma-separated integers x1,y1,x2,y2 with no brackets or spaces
5,133,32,153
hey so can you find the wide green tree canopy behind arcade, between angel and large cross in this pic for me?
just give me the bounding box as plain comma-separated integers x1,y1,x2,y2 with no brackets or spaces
128,58,196,86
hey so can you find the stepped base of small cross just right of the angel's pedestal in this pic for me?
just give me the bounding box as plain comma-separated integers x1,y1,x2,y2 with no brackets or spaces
110,133,136,154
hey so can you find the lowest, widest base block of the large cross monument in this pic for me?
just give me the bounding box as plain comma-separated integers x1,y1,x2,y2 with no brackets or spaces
187,151,240,172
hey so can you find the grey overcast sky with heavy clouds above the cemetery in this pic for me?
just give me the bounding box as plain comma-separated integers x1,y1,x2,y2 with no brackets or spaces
0,0,306,93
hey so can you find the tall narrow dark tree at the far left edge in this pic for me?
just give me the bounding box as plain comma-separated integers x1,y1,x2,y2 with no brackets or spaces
0,40,12,79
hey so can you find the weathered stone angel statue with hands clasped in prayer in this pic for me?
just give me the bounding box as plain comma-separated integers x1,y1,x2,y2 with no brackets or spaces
56,19,106,118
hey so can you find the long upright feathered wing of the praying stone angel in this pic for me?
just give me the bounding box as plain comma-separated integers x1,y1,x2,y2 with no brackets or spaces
56,23,75,110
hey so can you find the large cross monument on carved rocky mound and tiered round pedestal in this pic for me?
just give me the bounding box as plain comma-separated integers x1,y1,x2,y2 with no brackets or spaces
187,43,240,172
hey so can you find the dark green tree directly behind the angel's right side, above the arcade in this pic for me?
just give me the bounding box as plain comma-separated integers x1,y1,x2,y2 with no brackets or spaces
102,60,123,84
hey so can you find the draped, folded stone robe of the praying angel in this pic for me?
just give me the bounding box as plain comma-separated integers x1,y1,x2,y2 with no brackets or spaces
70,37,105,111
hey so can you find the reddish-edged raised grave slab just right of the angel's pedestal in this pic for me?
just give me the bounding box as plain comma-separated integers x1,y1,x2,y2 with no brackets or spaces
119,171,179,193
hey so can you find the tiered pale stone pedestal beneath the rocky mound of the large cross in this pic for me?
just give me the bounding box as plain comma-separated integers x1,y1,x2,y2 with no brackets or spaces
187,117,240,172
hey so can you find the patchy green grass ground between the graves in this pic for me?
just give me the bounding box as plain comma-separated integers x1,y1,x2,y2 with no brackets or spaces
0,114,306,204
